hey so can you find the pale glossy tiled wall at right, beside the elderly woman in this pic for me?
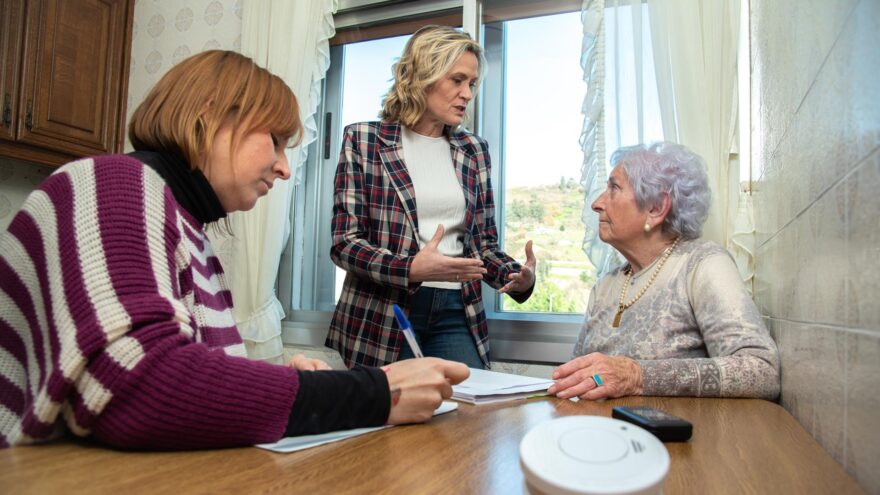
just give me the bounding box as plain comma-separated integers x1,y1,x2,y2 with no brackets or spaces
751,0,880,493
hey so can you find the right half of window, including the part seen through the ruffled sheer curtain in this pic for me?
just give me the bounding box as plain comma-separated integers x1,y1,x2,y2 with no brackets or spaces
480,0,662,321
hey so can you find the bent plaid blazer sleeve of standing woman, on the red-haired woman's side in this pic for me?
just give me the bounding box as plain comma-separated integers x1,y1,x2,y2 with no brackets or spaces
330,126,419,290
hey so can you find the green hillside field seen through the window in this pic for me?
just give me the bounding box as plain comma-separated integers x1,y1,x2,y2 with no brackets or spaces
498,179,596,313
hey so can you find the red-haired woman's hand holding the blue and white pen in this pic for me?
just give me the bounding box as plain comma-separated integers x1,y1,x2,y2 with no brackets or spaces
382,358,471,425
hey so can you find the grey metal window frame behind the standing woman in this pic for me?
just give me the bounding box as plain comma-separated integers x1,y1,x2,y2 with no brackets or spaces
278,1,588,364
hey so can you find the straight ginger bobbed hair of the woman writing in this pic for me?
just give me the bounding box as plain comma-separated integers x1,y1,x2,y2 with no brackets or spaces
128,50,303,169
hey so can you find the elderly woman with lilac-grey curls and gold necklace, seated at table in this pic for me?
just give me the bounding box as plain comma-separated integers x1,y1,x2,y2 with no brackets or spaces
550,143,779,399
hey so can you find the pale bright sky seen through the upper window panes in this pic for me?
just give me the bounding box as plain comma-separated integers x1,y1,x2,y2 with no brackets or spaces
340,7,662,187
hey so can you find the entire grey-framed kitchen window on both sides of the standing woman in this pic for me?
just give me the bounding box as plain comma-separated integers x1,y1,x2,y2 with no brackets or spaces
279,0,660,362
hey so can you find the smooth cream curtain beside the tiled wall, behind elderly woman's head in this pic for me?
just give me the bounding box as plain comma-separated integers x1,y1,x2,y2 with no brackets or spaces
648,0,740,246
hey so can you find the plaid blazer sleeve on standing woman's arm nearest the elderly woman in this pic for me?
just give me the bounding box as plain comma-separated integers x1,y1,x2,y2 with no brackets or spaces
474,139,534,303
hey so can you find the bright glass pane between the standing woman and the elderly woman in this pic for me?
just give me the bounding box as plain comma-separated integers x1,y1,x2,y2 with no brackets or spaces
480,12,596,319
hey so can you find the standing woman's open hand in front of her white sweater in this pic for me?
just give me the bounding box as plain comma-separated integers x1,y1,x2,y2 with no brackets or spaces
409,225,486,282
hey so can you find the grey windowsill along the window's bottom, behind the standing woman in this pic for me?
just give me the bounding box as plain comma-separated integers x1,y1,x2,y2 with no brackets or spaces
281,311,580,364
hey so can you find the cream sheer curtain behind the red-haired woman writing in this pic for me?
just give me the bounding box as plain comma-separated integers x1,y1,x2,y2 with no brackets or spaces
210,0,337,363
